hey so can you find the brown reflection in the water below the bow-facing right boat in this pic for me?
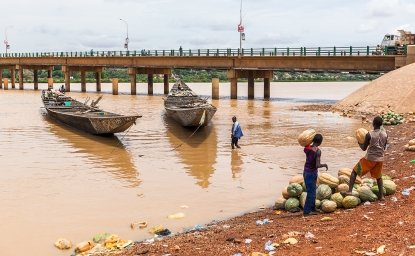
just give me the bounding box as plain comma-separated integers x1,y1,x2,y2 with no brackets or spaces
164,116,217,188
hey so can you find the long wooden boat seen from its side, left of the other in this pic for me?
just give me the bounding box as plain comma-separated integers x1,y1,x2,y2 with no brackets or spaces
42,91,141,135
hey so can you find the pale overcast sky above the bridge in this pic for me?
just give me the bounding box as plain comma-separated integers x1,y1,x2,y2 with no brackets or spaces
0,0,415,52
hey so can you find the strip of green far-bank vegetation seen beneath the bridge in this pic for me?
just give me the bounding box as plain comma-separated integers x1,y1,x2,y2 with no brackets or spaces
3,68,381,83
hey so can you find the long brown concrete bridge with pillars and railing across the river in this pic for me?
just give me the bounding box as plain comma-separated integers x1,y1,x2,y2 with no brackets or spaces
0,46,415,99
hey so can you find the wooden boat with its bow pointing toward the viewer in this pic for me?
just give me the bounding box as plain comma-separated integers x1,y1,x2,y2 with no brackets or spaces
164,80,216,126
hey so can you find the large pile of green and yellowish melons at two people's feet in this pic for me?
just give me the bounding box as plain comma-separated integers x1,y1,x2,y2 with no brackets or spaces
275,168,396,213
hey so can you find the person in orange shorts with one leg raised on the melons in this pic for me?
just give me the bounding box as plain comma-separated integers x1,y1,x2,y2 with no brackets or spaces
346,116,388,200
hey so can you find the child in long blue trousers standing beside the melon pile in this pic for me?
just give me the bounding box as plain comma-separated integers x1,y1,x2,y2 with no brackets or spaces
303,133,329,216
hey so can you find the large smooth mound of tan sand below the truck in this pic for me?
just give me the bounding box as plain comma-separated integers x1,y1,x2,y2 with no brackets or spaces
333,63,415,114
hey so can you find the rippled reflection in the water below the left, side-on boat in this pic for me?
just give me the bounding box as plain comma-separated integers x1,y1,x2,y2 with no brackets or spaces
42,113,141,187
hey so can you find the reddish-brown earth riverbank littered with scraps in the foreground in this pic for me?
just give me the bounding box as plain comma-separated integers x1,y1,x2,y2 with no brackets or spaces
97,121,415,255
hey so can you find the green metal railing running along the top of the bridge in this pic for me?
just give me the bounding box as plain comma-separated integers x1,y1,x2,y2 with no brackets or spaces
0,46,406,58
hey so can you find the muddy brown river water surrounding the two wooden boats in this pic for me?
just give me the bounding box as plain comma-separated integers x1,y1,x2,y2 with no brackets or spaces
0,82,370,256
